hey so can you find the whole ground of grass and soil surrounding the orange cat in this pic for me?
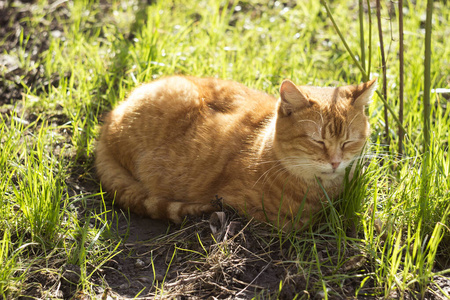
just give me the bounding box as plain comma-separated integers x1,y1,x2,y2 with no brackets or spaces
0,0,450,299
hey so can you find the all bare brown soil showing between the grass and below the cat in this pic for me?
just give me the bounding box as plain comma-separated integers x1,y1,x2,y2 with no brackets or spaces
0,0,450,299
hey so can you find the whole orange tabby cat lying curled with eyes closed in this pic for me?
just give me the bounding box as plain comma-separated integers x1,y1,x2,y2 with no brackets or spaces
96,76,376,227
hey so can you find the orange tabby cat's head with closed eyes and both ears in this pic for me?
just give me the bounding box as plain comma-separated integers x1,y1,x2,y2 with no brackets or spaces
274,79,377,180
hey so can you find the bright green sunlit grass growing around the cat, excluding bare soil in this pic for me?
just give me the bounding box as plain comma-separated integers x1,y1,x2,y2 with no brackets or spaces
0,0,450,299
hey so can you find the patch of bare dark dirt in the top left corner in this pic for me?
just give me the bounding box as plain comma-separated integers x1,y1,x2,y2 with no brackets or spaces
0,0,70,106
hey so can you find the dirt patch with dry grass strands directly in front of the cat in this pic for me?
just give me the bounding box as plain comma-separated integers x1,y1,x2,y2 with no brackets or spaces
94,211,365,299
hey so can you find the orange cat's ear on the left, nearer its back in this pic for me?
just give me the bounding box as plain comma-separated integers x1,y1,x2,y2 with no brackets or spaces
280,79,311,116
